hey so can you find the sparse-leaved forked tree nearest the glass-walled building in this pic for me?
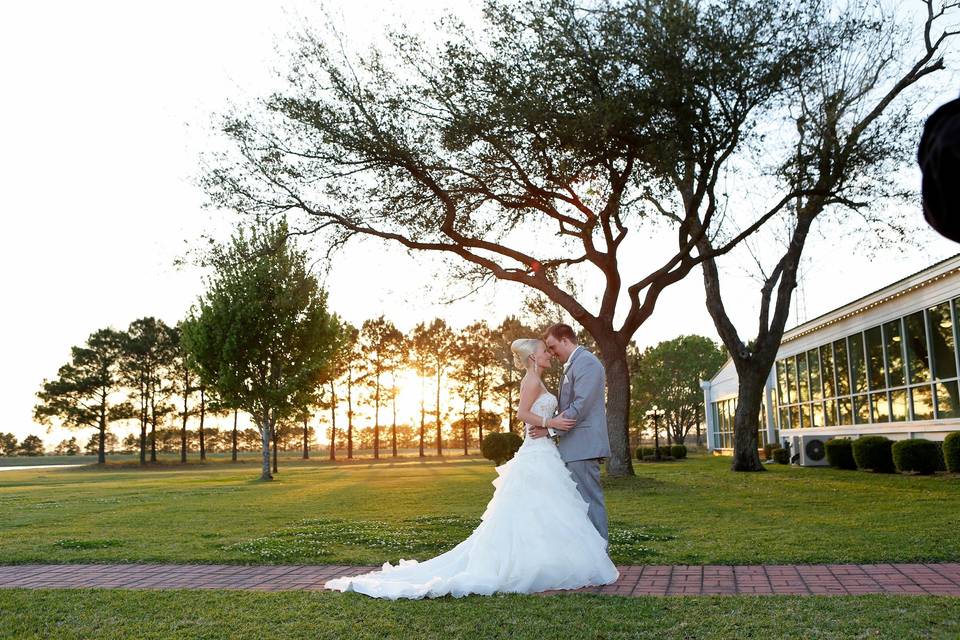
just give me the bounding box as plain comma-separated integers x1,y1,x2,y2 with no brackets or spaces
648,0,960,471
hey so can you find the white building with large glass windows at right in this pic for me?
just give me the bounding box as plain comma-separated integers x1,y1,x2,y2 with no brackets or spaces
701,255,960,460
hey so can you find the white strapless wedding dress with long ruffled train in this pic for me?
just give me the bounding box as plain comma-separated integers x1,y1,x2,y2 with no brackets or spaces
325,392,619,600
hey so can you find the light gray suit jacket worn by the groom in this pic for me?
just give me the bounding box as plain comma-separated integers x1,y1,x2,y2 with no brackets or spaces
557,348,610,462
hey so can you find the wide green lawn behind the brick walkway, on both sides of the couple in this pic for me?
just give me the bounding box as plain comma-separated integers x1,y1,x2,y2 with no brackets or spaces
0,457,960,564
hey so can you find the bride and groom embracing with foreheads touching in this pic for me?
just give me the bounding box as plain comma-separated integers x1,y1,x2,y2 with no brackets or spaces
326,324,619,600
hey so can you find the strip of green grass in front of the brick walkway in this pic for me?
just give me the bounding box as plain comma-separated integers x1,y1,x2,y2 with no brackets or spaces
0,590,960,640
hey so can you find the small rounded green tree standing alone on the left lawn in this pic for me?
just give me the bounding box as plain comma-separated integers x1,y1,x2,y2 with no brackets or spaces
182,221,340,479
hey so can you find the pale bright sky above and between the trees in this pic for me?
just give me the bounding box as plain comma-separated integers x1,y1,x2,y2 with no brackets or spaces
0,0,958,443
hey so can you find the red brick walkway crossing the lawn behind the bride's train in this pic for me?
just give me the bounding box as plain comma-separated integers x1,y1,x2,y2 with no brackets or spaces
0,563,960,596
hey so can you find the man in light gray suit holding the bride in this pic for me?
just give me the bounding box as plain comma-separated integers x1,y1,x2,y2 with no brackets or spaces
530,324,610,540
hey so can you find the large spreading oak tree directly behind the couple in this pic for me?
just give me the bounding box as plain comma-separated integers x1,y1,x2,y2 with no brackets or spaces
205,0,808,475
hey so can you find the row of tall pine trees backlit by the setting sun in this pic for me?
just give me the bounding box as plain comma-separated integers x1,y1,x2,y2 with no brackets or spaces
31,316,556,464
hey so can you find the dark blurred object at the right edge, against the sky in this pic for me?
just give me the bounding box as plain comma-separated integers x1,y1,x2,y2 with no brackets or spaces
917,94,960,242
